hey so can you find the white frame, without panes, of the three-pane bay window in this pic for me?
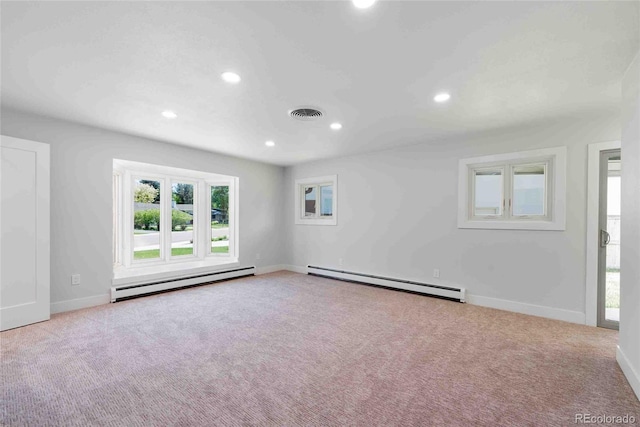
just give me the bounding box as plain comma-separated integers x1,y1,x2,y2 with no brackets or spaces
113,159,239,284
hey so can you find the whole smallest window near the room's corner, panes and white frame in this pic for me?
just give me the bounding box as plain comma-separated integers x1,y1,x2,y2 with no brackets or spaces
295,175,338,225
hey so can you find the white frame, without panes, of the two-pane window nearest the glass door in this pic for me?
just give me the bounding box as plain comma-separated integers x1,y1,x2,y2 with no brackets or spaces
458,147,567,230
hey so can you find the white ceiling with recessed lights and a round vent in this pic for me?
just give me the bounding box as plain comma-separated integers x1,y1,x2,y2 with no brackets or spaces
1,1,640,165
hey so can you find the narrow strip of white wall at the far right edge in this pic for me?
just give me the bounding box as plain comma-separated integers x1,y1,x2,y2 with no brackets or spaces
618,52,640,398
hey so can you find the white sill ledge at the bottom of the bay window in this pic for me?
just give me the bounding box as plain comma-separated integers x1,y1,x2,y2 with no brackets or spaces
111,257,240,286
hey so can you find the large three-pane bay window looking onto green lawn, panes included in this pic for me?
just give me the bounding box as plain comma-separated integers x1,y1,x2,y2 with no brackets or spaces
113,160,238,277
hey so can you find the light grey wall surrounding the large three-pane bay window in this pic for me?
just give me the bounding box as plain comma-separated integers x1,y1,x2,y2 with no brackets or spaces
1,110,284,311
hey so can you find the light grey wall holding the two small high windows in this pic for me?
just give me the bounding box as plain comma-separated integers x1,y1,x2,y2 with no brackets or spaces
285,117,620,323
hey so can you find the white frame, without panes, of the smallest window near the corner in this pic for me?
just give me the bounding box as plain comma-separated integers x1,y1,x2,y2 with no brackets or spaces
294,175,338,225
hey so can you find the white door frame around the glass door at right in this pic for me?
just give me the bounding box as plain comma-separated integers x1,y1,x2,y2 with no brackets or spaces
585,141,621,326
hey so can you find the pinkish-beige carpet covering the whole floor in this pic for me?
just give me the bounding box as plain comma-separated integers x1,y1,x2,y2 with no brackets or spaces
0,272,640,426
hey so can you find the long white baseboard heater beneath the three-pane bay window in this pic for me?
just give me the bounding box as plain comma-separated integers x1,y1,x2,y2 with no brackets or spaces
111,267,256,302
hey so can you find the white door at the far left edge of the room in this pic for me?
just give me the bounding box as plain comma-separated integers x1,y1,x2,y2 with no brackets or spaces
0,135,50,331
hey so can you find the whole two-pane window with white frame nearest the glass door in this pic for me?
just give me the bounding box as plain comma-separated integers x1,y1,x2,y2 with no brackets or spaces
458,147,566,230
